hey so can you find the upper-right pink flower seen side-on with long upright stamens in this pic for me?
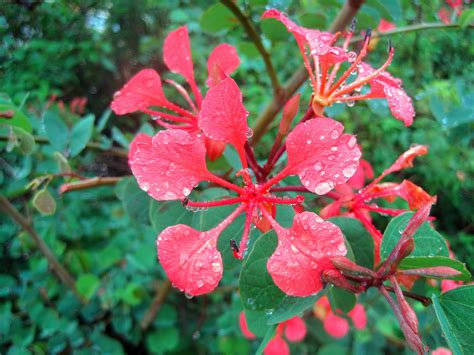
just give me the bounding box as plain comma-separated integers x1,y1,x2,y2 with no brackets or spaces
263,9,415,126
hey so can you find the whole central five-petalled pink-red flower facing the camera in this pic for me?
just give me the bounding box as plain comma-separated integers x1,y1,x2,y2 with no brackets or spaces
129,78,360,295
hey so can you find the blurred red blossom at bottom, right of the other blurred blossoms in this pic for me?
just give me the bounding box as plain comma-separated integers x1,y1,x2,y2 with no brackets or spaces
313,296,367,338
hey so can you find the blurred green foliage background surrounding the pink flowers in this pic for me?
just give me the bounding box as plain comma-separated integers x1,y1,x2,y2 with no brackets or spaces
0,0,474,354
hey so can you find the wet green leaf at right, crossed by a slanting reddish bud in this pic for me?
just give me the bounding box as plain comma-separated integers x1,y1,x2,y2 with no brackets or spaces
380,212,449,260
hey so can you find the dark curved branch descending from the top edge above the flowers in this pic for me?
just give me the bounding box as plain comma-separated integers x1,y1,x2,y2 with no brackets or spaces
221,0,281,97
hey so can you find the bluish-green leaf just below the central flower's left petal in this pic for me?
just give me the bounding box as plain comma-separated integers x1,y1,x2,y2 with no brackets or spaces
115,177,150,224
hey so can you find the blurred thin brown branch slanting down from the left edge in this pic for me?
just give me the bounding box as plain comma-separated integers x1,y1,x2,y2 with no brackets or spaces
0,195,86,304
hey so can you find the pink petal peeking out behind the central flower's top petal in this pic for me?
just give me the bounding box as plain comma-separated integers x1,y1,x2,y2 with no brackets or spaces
207,43,240,87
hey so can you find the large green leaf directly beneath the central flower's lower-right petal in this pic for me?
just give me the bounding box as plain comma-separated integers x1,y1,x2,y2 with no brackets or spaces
240,231,324,326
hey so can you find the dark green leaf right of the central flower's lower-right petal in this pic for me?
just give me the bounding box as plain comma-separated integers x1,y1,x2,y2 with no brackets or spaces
329,217,374,269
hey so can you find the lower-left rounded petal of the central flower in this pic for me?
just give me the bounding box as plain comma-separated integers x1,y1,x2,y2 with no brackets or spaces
156,224,223,296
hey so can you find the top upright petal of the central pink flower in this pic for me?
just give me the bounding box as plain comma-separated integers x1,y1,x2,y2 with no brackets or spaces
198,78,249,149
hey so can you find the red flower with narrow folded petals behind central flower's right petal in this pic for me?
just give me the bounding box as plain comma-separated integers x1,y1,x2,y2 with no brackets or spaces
321,145,432,263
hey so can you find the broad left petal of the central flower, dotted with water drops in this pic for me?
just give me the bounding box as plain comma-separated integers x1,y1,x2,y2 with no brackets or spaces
129,129,210,200
